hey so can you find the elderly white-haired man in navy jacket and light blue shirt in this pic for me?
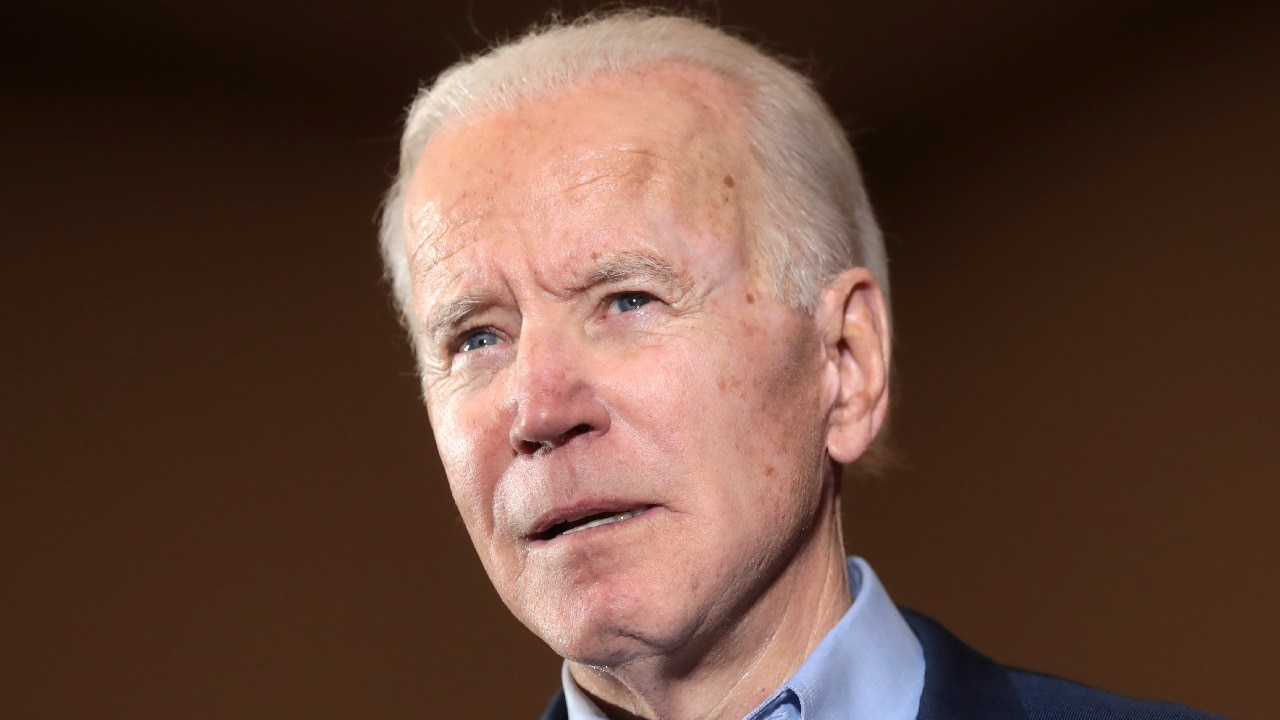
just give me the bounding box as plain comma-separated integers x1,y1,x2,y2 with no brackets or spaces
383,13,1218,720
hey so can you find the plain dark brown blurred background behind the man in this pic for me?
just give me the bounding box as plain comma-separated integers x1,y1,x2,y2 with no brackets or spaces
0,0,1280,719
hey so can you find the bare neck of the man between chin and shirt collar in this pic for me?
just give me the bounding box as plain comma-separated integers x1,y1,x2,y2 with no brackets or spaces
570,496,852,720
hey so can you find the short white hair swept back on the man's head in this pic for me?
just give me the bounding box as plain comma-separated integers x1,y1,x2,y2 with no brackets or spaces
380,10,888,333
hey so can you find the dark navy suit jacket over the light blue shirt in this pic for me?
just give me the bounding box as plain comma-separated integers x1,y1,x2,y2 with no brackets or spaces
543,610,1216,720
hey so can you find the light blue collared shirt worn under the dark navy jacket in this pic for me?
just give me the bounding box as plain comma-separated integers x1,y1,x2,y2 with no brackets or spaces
561,557,924,720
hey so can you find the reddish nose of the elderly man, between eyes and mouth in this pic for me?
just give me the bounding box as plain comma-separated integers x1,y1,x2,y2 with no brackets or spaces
509,320,609,455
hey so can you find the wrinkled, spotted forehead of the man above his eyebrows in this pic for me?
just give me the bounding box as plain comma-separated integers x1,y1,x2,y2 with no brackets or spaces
404,64,754,268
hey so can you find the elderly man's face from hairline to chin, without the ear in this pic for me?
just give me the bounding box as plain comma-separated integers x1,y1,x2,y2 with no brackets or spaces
406,68,835,665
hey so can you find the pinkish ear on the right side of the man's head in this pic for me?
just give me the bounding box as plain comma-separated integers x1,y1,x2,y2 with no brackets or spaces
815,268,890,465
